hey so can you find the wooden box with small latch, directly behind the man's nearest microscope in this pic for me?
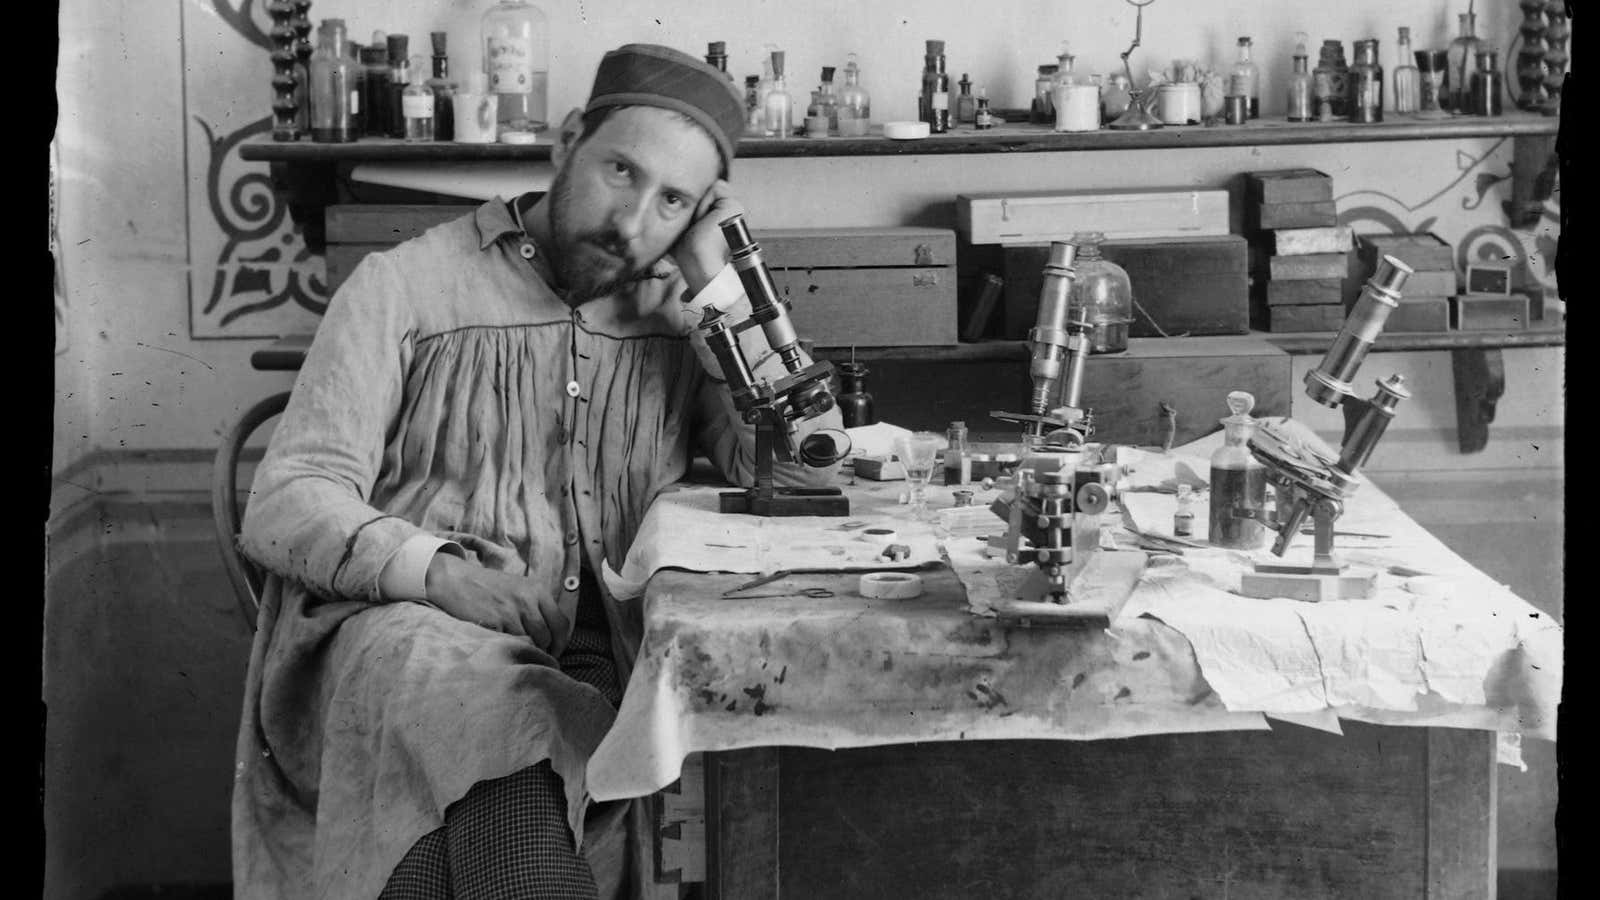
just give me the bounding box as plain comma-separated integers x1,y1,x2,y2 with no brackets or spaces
752,226,957,348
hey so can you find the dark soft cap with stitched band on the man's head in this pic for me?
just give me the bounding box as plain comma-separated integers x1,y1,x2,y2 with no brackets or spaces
584,43,744,167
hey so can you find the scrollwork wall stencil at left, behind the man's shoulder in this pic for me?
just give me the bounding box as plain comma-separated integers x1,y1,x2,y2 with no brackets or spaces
179,0,328,340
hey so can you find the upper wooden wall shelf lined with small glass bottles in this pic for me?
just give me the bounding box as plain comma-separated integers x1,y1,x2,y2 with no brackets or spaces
238,112,1560,162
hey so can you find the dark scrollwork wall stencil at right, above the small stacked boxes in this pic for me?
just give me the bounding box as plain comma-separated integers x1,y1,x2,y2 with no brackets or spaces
1338,139,1560,296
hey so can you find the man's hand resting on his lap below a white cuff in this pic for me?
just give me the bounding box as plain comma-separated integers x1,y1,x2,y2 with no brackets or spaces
427,552,570,657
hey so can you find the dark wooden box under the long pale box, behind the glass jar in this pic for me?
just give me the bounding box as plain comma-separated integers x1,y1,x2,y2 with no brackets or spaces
1005,234,1250,340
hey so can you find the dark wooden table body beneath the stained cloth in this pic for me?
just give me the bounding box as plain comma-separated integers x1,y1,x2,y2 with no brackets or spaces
624,560,1496,900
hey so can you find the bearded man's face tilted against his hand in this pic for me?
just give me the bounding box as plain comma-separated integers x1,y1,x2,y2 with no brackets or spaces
550,106,720,303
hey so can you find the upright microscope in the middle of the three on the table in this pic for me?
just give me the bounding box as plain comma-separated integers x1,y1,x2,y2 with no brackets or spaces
989,240,1146,625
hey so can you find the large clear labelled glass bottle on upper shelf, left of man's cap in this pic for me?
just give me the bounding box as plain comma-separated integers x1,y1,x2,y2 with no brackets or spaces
483,0,550,133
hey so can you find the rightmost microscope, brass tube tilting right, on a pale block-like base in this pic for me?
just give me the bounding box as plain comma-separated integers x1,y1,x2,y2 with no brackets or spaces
1234,256,1411,601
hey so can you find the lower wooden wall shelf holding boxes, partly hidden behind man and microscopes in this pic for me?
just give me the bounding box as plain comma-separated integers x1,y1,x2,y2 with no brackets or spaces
250,328,1566,372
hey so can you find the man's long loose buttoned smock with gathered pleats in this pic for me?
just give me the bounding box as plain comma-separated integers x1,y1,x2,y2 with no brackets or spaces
232,199,840,900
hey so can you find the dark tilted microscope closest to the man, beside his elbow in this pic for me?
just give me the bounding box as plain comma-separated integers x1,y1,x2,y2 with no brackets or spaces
698,216,850,516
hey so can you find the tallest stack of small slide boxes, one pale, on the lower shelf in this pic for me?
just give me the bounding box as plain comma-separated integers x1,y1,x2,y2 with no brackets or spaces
1245,168,1350,331
